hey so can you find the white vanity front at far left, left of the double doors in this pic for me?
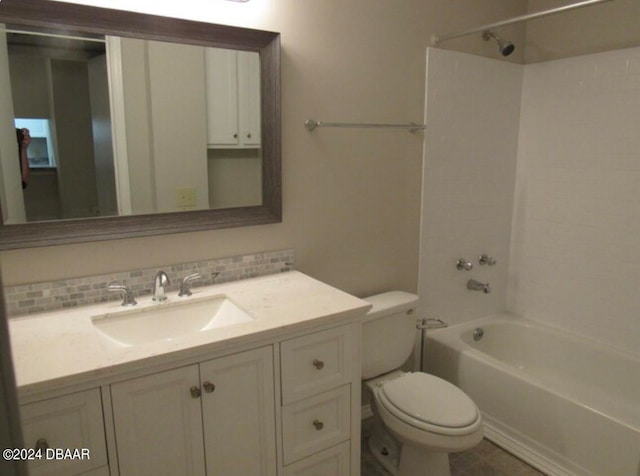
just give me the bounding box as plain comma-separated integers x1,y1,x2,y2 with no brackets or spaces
20,388,107,475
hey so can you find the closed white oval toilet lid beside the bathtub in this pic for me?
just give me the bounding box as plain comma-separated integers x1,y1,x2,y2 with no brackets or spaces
380,372,479,428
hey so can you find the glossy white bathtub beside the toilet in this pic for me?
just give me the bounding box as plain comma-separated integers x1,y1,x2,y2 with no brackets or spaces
424,315,640,476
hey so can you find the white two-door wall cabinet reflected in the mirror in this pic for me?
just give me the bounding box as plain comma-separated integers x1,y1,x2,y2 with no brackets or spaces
205,48,260,148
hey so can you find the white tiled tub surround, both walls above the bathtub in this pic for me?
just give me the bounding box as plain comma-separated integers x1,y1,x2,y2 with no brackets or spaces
419,47,640,351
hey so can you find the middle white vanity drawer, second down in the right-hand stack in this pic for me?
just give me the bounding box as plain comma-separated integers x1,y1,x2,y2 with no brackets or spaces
282,385,351,465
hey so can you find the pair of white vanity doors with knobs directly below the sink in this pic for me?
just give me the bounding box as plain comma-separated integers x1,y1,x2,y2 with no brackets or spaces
111,346,276,476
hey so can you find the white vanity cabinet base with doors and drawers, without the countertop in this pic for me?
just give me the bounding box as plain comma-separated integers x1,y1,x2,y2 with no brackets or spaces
16,324,360,476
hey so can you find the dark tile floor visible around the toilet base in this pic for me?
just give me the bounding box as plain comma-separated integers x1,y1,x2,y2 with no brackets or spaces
361,419,544,476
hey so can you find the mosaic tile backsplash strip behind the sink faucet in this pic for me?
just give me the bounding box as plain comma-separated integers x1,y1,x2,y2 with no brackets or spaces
4,249,295,317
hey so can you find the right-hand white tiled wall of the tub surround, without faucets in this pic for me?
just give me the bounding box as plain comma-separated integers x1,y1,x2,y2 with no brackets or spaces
509,48,640,351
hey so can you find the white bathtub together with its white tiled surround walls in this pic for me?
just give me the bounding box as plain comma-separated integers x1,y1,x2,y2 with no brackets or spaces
419,41,640,476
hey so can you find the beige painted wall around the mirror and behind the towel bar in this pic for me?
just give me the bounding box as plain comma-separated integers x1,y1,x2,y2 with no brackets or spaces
1,0,526,295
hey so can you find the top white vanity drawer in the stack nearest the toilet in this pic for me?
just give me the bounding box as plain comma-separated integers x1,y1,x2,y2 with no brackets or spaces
280,326,353,405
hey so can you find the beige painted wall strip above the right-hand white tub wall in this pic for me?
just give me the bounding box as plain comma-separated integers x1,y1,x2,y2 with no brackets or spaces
525,0,640,63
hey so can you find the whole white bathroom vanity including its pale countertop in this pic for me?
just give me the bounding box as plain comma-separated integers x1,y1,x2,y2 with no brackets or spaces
9,271,370,476
